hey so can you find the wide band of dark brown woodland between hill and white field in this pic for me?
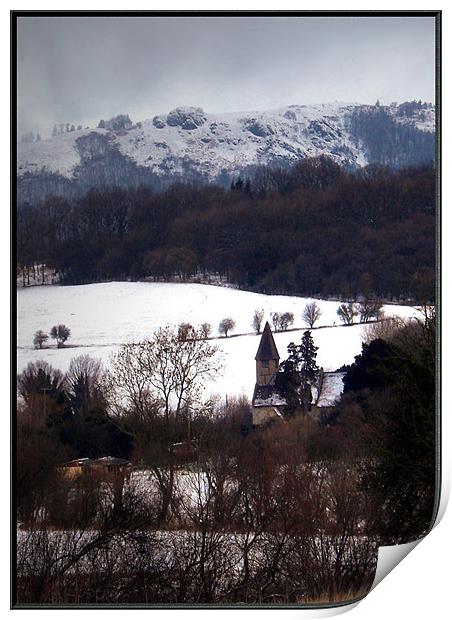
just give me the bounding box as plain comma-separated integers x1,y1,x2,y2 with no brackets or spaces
17,158,435,300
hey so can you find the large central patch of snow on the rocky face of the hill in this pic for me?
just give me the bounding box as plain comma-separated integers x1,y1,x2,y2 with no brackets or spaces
118,102,366,177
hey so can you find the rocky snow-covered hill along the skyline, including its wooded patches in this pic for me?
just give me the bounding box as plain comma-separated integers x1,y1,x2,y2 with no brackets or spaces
17,102,435,202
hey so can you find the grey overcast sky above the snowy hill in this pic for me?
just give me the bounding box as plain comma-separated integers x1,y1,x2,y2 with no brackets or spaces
17,16,435,135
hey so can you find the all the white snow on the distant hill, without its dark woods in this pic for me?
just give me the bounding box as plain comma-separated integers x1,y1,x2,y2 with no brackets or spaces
17,101,435,179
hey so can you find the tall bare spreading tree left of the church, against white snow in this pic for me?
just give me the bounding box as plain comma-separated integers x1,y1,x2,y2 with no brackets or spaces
109,326,221,522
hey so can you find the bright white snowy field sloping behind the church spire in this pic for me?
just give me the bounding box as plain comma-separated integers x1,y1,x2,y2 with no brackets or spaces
17,282,419,398
